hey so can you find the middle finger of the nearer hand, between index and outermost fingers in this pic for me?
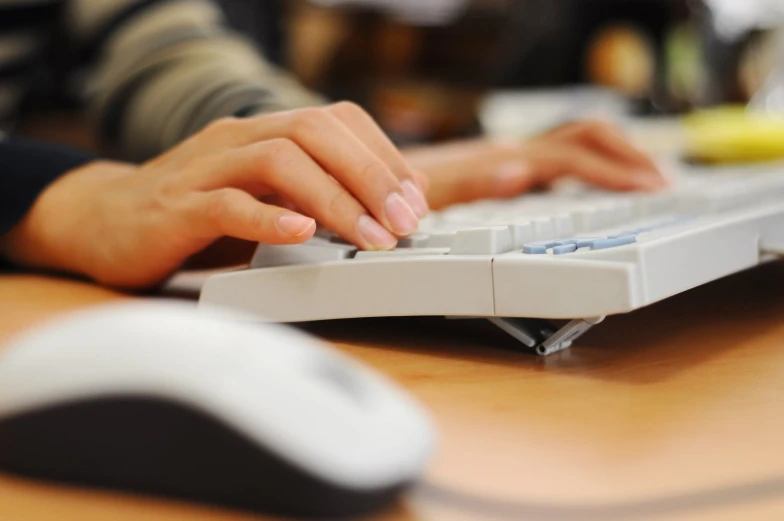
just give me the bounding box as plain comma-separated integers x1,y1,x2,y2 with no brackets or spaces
207,109,419,237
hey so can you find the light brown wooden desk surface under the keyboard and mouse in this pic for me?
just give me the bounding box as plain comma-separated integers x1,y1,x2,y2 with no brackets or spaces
0,263,784,521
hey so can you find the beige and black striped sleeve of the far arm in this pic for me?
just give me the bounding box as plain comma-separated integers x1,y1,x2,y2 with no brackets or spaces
66,0,323,161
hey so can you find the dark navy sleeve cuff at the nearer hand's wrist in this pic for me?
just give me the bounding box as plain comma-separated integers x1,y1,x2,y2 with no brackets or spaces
0,139,96,235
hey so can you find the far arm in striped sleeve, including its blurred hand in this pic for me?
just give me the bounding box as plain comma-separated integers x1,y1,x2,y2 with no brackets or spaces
61,0,661,208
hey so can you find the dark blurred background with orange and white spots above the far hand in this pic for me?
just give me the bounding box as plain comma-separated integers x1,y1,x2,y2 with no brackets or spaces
216,0,784,143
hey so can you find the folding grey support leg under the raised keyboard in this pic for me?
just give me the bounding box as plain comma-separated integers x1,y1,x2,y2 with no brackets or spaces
488,317,604,356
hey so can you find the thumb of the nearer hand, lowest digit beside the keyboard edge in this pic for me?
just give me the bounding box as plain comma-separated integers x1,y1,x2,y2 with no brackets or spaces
189,188,316,244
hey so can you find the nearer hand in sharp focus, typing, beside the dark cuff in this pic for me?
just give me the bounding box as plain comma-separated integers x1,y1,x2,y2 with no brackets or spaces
0,103,428,288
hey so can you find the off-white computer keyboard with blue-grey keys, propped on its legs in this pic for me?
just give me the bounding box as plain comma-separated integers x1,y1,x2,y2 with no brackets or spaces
201,164,784,354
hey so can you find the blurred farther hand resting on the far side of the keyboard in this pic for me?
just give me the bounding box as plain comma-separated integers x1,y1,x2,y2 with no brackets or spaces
405,121,666,209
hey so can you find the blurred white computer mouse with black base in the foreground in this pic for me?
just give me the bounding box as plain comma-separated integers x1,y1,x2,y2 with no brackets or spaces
0,302,435,516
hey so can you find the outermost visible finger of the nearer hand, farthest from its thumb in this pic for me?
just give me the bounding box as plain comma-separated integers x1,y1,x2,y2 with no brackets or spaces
326,102,430,217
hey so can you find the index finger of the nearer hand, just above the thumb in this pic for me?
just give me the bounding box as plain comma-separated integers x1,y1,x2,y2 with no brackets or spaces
196,139,398,250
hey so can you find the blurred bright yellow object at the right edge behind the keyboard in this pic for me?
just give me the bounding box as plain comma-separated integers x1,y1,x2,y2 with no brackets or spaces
683,106,784,163
